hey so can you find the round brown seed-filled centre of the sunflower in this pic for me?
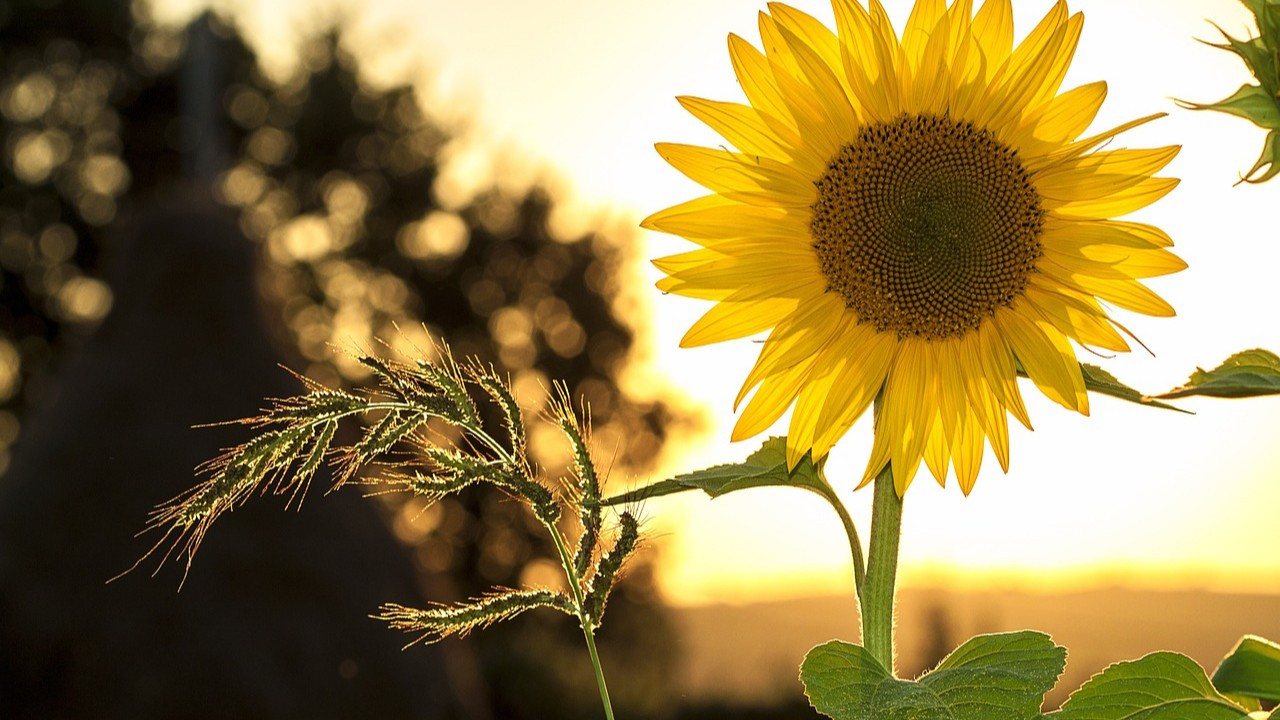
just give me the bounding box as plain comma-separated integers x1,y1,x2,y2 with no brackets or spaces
809,115,1044,340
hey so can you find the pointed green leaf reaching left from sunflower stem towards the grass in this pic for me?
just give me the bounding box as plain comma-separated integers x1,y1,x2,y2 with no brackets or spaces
603,437,828,505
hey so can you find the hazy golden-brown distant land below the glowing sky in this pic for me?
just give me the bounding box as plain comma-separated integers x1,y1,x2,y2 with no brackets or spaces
673,587,1280,707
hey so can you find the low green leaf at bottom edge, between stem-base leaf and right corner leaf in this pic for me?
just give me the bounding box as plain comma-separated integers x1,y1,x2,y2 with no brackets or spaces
1048,652,1248,720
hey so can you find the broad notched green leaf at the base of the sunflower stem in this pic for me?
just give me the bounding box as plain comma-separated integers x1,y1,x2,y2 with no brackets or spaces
800,630,1066,720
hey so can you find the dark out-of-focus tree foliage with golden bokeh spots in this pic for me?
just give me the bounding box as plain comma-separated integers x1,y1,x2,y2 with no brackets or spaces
0,0,690,717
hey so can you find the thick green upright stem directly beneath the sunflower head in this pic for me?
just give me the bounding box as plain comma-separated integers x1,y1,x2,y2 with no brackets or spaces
861,465,902,675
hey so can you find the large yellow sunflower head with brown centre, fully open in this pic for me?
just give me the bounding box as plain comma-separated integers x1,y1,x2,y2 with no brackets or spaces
641,0,1185,495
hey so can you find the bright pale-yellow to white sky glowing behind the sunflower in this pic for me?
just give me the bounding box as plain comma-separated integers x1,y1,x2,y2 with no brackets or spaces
161,0,1280,602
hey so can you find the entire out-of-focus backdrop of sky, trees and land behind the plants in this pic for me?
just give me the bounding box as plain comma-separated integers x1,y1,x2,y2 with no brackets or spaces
0,0,1280,719
